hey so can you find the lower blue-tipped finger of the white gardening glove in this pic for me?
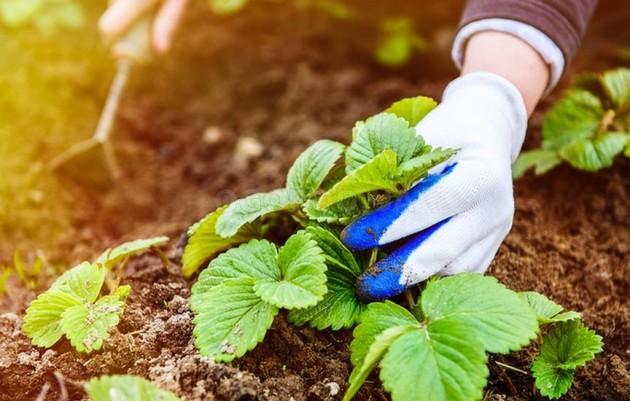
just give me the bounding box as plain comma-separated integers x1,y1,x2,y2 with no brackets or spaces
356,210,511,301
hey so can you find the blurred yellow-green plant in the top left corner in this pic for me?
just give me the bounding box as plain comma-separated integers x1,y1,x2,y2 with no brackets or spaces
0,0,85,33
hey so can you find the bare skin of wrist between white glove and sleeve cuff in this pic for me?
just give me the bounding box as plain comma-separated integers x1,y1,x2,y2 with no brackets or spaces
462,31,550,115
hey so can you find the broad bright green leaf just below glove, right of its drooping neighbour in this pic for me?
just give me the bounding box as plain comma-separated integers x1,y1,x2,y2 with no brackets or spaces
421,273,538,353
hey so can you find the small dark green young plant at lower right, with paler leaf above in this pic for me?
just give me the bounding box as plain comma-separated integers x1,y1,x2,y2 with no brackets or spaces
521,292,603,399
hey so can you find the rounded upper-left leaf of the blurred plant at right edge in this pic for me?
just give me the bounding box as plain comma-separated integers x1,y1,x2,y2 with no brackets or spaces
542,89,604,149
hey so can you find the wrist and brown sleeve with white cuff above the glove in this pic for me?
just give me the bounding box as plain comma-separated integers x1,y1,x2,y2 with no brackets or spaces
453,0,597,114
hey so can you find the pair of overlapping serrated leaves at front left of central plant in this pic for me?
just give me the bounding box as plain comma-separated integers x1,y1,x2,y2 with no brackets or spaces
190,231,327,362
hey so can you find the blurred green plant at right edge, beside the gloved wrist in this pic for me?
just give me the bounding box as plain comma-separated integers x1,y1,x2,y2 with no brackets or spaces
513,68,630,178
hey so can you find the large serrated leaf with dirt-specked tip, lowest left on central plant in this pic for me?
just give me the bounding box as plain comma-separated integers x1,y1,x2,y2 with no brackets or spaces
190,277,278,362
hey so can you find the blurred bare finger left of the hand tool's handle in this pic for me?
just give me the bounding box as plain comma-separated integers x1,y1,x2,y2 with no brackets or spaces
98,0,159,41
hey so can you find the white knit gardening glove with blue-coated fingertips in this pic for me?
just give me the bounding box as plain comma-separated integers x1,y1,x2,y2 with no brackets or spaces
342,72,527,301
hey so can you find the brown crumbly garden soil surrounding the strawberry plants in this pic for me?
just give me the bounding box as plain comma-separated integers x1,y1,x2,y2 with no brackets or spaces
0,2,630,401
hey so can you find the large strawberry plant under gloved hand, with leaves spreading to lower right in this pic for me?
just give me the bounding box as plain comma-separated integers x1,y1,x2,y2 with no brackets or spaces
183,97,601,401
